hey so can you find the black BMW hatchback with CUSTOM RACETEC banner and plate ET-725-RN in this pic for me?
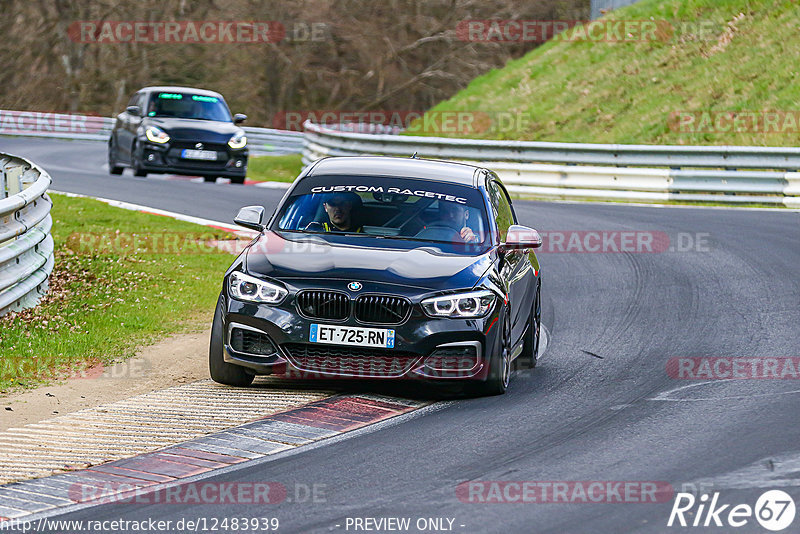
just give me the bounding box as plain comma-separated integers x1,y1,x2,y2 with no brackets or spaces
209,157,542,394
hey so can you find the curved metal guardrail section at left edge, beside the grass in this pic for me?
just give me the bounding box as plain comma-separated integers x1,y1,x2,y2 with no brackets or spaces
0,153,53,316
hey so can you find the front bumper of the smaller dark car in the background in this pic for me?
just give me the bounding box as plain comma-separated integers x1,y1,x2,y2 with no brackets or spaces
136,140,249,178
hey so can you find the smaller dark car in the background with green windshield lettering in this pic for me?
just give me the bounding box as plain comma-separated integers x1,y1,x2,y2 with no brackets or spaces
108,87,248,184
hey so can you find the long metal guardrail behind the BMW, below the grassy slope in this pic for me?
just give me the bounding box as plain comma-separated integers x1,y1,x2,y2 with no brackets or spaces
303,122,800,208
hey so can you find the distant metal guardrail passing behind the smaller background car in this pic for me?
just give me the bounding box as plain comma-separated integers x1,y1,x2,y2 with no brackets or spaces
0,110,303,156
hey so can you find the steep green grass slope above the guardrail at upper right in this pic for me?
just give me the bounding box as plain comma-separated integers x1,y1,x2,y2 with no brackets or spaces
417,0,800,146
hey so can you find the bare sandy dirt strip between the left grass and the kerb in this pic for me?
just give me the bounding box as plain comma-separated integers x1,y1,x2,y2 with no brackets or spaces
0,327,210,432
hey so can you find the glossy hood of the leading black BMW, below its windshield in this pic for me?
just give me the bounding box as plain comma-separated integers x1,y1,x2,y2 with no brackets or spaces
245,232,491,291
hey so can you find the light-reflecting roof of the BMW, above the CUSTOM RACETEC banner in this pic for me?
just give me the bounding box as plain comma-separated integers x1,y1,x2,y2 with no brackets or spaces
306,156,485,187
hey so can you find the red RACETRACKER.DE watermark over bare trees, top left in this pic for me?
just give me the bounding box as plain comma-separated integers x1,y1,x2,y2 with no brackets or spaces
67,20,330,44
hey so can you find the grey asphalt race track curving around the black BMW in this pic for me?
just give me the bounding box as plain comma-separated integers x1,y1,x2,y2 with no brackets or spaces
0,138,800,533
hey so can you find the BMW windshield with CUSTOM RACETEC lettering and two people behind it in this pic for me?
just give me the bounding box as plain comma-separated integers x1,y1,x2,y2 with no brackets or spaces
273,175,489,244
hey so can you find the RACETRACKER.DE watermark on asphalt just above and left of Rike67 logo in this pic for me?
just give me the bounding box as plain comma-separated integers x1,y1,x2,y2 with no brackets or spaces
456,480,674,504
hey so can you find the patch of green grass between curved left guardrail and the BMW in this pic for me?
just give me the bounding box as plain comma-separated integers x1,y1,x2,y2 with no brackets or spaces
0,195,232,393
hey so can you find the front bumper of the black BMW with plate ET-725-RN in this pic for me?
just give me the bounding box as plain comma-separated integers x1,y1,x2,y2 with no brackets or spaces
223,284,500,381
